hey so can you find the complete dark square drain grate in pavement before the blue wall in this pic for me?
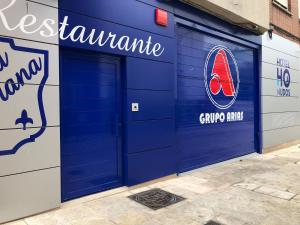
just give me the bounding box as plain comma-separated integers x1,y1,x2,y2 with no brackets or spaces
128,188,185,210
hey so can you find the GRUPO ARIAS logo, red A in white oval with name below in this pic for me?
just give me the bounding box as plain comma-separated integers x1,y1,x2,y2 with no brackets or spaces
199,45,244,124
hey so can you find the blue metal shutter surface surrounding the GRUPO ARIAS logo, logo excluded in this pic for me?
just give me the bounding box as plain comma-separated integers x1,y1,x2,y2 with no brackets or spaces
176,26,258,172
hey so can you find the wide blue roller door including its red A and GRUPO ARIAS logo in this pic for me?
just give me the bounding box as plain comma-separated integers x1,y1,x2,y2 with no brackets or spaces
176,26,258,172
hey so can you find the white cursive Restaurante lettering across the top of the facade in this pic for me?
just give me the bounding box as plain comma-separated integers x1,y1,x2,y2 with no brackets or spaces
0,0,164,57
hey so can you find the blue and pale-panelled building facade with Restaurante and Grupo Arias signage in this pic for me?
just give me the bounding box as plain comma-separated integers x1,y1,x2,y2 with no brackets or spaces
0,0,300,223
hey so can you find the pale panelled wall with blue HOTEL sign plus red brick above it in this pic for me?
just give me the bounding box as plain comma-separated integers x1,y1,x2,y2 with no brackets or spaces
261,0,300,151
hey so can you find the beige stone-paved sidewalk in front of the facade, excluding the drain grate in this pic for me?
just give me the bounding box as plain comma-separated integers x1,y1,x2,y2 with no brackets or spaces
5,145,300,225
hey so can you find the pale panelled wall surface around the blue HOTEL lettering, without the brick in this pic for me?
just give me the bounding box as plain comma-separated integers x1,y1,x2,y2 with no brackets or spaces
261,33,300,149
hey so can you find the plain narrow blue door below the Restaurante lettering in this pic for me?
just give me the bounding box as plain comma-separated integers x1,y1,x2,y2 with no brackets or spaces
60,49,122,201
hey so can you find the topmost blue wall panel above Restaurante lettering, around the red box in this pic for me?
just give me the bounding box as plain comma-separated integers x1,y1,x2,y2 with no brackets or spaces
59,0,174,37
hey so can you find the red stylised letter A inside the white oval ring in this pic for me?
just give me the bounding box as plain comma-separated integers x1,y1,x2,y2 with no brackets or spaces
209,49,235,96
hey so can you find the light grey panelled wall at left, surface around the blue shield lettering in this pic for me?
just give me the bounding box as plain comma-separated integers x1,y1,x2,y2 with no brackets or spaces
0,0,60,223
